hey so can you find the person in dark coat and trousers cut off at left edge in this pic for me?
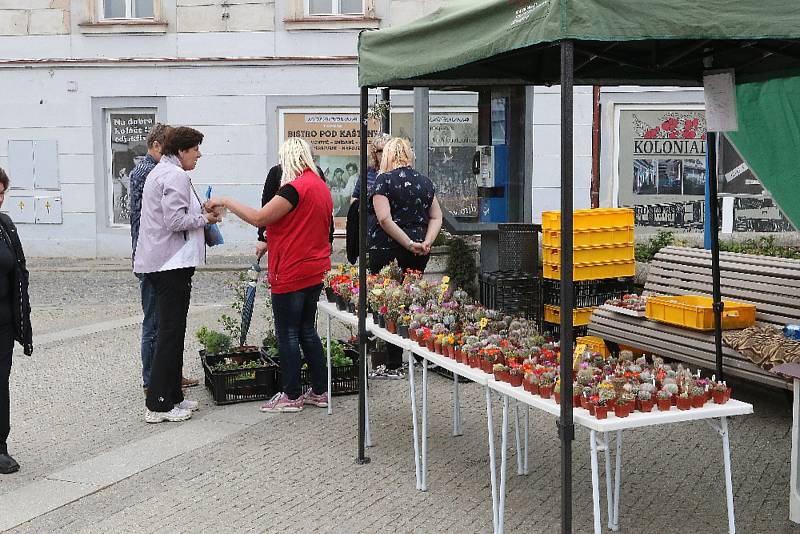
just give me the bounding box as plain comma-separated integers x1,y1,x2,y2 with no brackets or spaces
0,169,33,475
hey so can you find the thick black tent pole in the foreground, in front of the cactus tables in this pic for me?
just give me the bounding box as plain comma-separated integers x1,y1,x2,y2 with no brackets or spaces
557,40,575,534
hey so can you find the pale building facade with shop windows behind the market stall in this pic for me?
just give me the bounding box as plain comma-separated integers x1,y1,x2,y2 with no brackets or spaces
0,0,785,257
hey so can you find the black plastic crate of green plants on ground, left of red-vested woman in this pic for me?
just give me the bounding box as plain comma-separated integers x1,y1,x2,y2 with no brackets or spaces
200,347,280,404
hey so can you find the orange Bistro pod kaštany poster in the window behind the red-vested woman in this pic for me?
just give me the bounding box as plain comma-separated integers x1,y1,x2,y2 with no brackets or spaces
283,113,379,222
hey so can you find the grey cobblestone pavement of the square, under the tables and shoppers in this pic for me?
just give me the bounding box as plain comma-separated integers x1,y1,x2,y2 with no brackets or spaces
0,264,800,534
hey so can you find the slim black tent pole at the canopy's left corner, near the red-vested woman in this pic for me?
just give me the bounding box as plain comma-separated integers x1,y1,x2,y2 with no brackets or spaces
356,87,369,464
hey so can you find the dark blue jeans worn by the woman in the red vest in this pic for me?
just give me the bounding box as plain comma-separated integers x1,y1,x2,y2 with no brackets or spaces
272,284,328,400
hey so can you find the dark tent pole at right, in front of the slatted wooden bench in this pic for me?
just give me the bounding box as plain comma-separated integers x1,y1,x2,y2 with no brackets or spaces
706,132,725,380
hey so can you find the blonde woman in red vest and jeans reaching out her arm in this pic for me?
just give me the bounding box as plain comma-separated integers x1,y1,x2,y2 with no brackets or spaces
207,137,333,413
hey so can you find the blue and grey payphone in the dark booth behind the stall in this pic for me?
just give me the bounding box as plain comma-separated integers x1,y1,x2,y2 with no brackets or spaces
472,145,508,223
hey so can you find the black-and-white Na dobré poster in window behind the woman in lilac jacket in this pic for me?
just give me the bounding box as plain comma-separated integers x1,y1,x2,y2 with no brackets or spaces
109,112,156,224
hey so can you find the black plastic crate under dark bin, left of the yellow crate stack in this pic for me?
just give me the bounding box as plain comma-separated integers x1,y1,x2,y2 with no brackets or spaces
480,271,542,322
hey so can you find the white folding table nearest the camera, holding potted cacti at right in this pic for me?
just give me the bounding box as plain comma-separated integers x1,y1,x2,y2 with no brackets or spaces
488,379,753,534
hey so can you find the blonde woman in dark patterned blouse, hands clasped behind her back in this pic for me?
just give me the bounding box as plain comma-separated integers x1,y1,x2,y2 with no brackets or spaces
368,137,442,378
